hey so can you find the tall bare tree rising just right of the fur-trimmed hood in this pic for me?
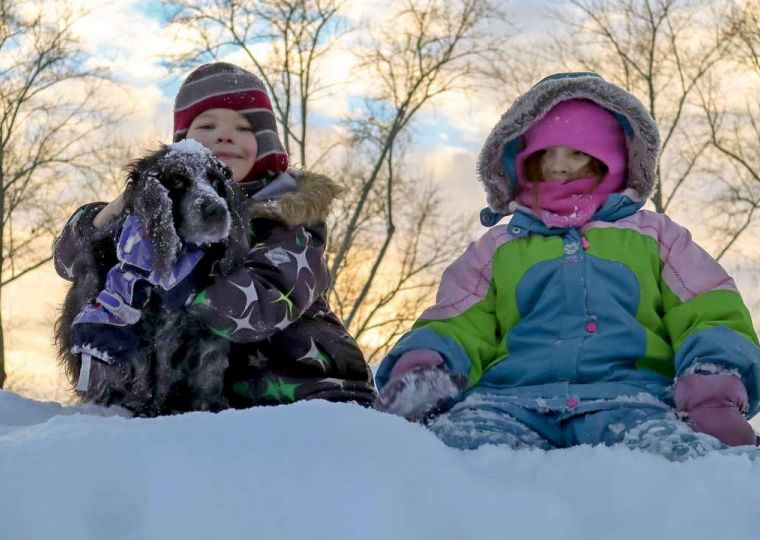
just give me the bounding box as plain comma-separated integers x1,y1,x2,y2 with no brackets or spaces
553,0,730,212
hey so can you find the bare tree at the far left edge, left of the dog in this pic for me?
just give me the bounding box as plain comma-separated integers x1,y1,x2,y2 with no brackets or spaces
0,0,123,386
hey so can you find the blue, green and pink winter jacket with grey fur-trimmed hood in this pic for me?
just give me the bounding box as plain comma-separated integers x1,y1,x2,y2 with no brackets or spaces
376,74,760,416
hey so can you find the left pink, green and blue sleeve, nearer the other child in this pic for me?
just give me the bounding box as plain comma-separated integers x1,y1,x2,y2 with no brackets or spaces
375,227,510,388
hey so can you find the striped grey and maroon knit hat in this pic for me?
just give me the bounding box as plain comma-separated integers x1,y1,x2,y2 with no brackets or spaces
174,62,288,182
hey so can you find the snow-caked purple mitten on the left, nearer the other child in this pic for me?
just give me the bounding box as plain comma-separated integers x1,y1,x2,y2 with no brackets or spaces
374,349,467,422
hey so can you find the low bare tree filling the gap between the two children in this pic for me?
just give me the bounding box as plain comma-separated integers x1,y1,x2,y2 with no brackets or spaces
328,139,474,361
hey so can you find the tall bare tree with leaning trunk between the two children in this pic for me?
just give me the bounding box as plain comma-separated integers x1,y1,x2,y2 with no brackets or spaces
330,0,500,320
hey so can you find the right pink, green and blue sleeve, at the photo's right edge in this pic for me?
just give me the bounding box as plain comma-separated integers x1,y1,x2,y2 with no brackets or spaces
660,216,760,416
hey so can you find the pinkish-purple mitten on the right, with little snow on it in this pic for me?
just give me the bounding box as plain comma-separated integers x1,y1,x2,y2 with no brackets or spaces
674,373,757,446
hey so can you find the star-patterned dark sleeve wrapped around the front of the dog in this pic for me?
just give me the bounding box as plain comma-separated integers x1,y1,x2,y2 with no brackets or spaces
187,220,330,342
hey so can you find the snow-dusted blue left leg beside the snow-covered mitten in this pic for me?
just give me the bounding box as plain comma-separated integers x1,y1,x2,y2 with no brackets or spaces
428,399,555,450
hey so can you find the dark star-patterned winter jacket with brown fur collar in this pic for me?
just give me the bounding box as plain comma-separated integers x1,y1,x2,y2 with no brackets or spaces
54,171,375,408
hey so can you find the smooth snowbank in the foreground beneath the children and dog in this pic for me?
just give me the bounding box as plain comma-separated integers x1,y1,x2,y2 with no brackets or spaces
0,391,760,540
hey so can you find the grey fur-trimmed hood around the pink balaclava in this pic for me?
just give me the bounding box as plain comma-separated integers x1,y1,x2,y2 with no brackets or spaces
478,72,660,214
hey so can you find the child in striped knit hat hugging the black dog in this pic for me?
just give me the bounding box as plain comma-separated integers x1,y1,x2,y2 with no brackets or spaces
54,62,375,412
